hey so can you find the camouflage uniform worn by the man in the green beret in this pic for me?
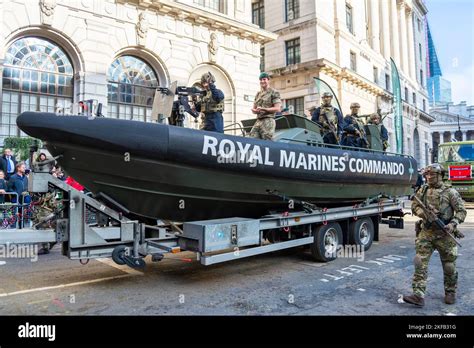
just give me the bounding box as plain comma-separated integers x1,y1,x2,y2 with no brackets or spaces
250,88,281,140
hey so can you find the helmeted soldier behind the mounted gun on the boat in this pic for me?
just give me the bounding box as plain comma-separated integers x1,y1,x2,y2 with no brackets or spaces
196,72,224,133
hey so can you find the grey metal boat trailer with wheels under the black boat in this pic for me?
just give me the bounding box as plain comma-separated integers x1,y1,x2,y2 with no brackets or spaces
0,171,403,268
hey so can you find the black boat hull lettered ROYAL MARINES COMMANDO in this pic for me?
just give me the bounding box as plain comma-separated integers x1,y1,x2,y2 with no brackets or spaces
18,113,416,221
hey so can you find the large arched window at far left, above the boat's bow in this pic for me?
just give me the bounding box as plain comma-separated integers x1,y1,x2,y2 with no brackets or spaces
0,37,74,143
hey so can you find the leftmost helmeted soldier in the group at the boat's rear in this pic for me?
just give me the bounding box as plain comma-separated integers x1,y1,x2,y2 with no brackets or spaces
311,92,343,145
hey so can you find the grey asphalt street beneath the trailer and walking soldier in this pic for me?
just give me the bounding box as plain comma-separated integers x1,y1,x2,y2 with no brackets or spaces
0,207,474,315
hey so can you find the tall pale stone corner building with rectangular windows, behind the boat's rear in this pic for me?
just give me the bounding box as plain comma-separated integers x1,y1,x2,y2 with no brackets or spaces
253,0,434,166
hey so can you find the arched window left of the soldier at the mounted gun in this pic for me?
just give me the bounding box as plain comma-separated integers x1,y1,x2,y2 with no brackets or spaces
107,56,158,121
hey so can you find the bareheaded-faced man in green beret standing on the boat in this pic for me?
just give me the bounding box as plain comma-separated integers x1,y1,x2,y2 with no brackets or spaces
250,72,281,140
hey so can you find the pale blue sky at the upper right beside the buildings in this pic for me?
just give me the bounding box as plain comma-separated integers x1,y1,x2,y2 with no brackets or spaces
425,0,474,105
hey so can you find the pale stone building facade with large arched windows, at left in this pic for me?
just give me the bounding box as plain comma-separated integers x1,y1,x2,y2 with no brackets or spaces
0,0,276,145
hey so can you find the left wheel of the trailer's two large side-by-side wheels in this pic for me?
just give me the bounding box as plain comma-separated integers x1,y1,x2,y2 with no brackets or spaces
310,222,342,262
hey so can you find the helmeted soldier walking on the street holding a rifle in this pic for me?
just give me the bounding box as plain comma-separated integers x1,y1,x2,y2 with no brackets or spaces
403,163,466,307
